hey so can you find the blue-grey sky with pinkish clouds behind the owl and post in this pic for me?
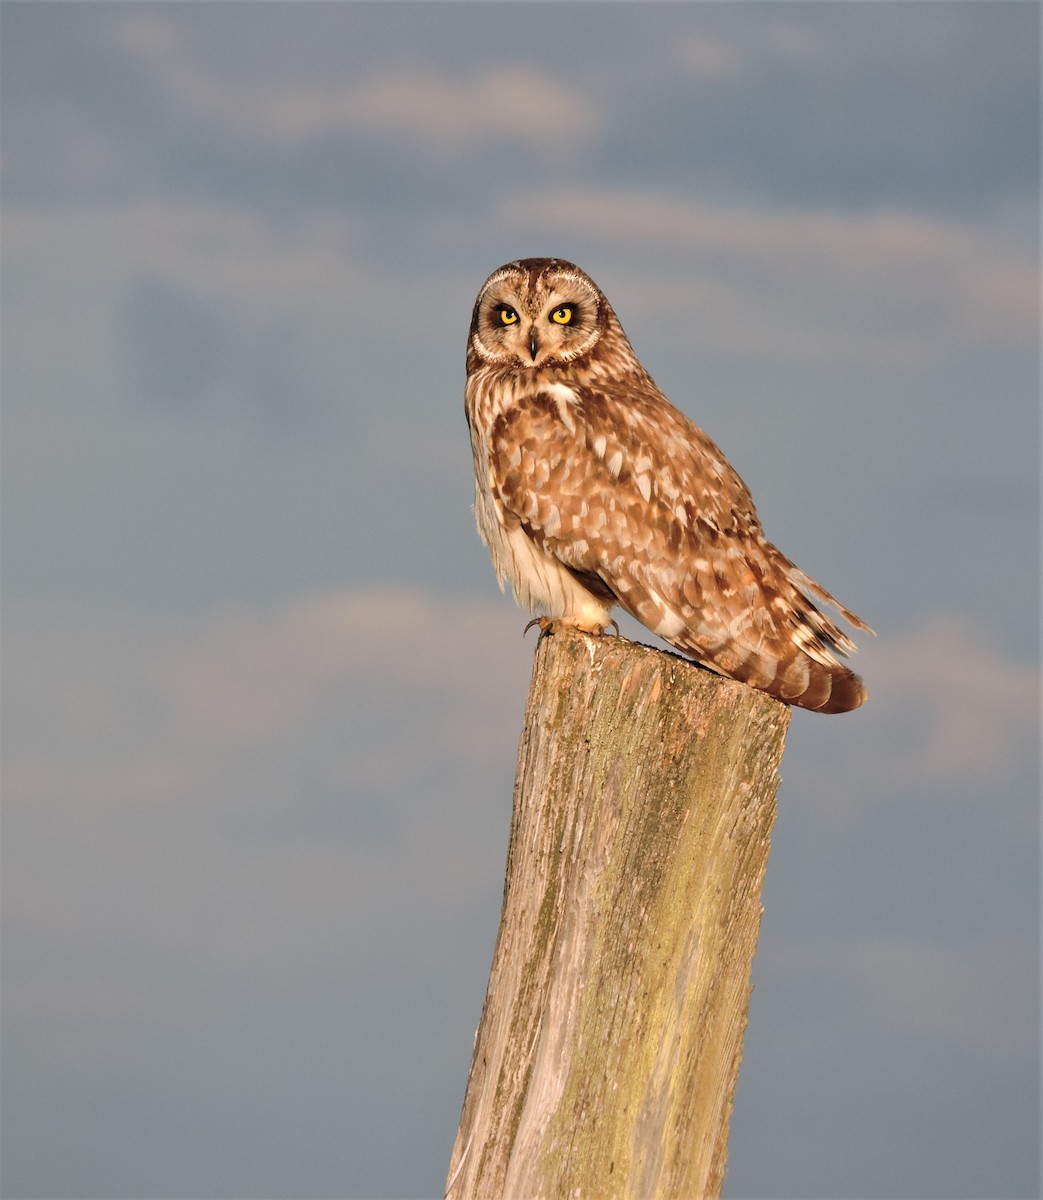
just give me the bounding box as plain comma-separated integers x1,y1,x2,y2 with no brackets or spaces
0,7,1039,1200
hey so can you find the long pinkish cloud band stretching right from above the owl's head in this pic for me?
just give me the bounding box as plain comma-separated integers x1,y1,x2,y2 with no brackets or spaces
491,187,1039,364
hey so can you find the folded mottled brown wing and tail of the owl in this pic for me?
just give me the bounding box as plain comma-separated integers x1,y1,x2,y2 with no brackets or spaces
488,380,868,712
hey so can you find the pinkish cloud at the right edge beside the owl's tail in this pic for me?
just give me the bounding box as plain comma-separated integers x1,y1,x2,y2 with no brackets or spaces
783,612,1039,869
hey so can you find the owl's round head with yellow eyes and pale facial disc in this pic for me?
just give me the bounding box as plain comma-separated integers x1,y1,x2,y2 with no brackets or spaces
467,258,633,373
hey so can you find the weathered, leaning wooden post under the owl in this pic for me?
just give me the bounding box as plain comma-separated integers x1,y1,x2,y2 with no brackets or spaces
446,630,790,1200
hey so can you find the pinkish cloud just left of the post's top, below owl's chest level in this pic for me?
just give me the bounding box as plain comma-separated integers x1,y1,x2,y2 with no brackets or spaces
148,592,523,769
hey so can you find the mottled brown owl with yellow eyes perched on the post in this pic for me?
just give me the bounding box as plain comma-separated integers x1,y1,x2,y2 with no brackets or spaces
464,258,871,713
